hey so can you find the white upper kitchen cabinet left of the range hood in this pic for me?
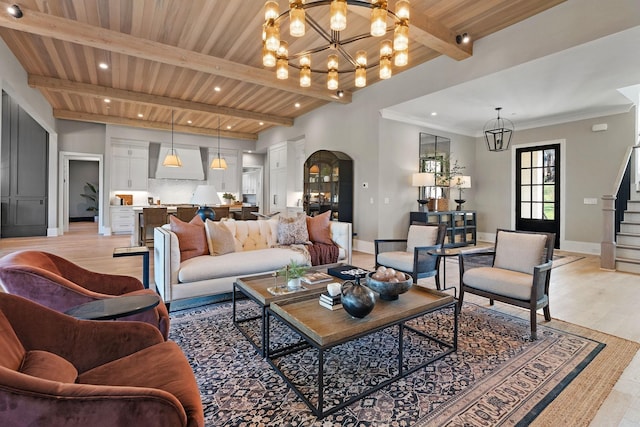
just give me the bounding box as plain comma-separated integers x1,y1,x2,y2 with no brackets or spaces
111,143,149,191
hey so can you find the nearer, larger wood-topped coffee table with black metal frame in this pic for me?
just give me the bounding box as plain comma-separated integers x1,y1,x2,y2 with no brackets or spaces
265,286,458,418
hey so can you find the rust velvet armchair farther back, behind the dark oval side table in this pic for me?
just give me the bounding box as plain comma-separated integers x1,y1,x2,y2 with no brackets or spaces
0,251,169,339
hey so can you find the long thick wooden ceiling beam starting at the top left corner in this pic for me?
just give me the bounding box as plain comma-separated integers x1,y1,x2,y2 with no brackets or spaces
0,2,351,104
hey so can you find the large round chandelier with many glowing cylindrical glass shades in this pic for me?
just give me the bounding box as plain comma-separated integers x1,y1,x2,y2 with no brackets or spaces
262,0,410,90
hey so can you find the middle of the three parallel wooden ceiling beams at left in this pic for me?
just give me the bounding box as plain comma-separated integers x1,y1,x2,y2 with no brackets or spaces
29,75,293,127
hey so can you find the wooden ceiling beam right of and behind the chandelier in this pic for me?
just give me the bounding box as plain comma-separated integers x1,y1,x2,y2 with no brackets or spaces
349,7,473,61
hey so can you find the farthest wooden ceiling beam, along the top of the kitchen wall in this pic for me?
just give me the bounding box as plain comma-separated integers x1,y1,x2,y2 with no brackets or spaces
53,110,258,141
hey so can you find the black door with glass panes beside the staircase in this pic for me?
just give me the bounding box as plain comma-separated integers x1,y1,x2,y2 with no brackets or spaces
516,144,560,248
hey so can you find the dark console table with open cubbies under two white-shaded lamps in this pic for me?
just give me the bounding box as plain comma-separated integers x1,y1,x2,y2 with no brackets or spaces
409,211,476,248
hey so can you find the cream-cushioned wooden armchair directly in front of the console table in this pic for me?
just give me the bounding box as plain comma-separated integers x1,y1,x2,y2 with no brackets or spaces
374,223,447,289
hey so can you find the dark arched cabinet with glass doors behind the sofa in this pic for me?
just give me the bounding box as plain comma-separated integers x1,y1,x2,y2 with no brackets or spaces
303,150,353,222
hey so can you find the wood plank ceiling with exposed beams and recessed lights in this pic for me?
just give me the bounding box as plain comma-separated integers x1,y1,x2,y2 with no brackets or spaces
0,0,564,144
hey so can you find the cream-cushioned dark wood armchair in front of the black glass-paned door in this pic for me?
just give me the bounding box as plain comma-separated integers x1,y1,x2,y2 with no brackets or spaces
458,229,555,340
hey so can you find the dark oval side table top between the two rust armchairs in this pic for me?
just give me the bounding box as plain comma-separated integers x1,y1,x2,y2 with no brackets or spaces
64,294,160,320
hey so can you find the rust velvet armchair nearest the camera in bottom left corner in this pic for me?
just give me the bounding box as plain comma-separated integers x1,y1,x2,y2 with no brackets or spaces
0,292,204,427
